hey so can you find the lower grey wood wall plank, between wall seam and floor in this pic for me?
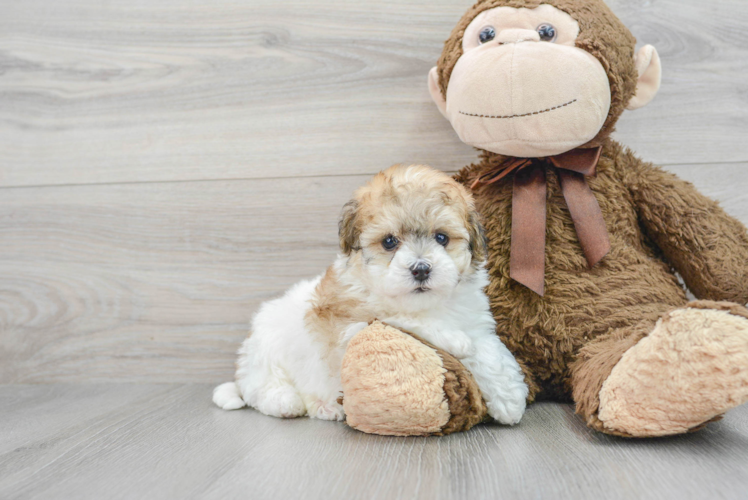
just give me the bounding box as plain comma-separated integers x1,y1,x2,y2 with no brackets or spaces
0,163,748,383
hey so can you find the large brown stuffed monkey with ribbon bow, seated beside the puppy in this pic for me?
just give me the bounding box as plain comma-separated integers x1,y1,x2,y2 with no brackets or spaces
343,0,748,437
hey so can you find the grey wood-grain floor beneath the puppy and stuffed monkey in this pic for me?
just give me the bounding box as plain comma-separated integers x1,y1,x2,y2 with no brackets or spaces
0,384,748,500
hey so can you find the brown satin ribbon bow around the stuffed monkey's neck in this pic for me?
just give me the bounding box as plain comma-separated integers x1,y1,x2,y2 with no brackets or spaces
470,147,610,296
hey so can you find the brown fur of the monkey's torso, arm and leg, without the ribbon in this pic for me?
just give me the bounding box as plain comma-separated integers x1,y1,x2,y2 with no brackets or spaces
457,140,748,430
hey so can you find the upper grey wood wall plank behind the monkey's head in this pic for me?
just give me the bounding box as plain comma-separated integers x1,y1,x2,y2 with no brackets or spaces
0,0,748,186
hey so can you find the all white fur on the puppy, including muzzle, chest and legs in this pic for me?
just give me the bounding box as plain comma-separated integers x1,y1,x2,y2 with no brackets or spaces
213,173,528,424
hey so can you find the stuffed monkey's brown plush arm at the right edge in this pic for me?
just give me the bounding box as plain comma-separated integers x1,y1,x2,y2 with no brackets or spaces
618,151,748,304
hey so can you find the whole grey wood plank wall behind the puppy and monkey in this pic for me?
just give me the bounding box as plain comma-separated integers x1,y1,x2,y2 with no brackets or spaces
0,0,748,383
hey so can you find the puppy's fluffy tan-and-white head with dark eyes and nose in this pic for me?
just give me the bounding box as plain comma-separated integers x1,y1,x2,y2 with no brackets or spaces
340,165,486,310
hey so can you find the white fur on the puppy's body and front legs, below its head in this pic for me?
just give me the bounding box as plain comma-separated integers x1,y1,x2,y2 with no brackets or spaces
213,257,527,424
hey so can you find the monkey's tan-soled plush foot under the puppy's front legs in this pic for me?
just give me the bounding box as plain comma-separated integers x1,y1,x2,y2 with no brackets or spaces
341,322,486,436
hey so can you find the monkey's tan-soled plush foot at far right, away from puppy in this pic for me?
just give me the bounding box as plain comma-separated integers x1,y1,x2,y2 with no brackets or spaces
598,302,748,437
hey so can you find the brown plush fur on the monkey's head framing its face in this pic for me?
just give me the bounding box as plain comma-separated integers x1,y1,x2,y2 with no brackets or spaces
437,0,638,147
